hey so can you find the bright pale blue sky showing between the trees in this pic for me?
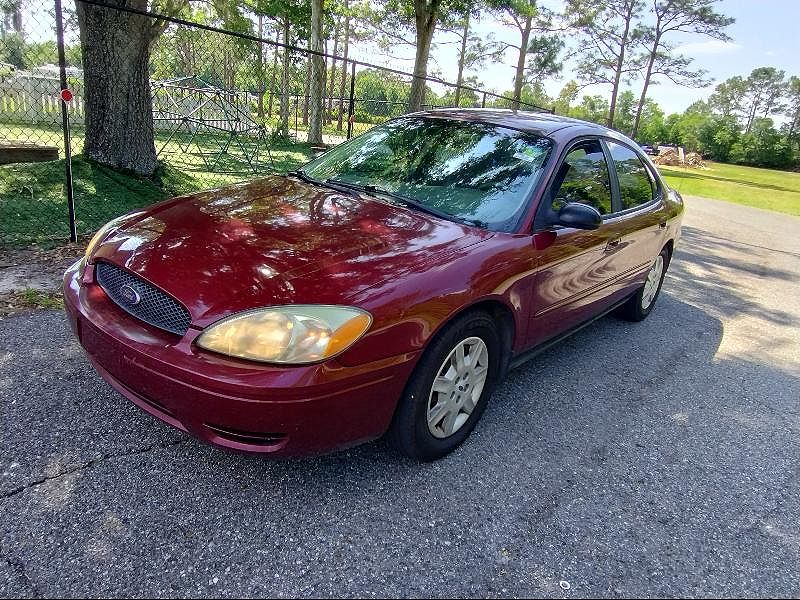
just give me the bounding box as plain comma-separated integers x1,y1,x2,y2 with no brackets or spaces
350,0,800,114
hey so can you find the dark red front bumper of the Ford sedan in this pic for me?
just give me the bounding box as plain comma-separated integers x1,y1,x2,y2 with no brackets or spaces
64,263,417,457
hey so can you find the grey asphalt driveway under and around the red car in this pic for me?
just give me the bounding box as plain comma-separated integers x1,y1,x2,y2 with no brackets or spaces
0,199,800,597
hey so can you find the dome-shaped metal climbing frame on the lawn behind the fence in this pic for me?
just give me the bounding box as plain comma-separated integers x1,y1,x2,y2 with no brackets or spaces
151,76,275,173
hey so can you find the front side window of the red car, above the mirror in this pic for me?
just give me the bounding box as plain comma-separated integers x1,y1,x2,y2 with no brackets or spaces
553,140,612,215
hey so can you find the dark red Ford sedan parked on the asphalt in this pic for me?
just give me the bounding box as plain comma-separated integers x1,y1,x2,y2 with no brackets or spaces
64,109,683,460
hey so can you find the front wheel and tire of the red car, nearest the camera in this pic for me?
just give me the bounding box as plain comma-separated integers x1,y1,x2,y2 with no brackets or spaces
387,312,503,462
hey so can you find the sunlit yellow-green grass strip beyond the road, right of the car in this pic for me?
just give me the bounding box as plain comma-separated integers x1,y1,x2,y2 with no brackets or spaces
659,162,800,216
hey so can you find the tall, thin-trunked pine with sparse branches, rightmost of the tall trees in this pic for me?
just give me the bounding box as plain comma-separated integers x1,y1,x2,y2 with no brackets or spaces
631,0,734,137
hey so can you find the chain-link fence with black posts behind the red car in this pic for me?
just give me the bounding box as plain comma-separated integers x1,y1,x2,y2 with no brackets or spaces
0,0,543,247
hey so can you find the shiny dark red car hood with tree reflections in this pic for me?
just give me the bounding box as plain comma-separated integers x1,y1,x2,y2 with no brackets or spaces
92,176,492,327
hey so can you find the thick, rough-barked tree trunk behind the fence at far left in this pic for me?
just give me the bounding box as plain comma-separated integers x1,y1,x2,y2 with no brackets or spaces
76,0,163,176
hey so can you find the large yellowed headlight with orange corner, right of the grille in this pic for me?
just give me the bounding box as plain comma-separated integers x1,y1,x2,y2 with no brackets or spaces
197,304,372,364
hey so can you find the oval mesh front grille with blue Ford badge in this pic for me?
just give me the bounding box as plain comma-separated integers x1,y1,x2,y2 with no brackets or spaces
95,262,191,336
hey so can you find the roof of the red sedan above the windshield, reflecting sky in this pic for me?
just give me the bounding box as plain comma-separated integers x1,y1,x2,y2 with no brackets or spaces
414,108,608,137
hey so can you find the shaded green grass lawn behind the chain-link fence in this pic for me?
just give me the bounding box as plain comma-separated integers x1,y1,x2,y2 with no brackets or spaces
0,124,310,247
